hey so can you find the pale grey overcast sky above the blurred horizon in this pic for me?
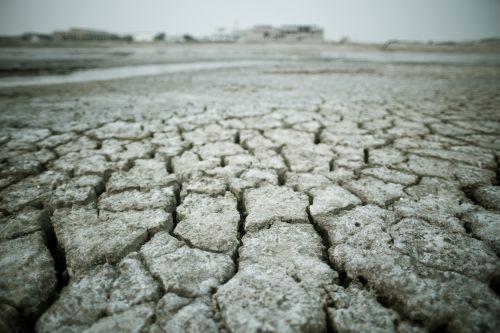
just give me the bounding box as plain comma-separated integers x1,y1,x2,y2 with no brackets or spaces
0,0,500,42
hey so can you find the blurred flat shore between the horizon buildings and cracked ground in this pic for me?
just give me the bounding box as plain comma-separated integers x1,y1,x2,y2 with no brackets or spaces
0,41,500,77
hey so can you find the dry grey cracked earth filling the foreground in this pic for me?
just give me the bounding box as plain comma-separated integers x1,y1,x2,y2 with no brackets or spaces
0,44,500,333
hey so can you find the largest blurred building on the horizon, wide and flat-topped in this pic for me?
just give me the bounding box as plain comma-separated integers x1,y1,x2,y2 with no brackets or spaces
239,25,323,43
